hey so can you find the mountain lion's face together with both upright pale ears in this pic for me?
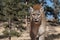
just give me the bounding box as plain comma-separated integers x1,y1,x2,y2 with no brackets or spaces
30,5,43,23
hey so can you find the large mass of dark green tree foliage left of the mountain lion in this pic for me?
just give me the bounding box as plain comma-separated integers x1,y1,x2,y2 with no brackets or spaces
1,0,32,21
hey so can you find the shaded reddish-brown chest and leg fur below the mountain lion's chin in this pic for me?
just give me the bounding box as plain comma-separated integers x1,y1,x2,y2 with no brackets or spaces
30,22,40,40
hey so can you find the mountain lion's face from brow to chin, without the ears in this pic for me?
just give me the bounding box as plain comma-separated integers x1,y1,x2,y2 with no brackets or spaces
31,10,41,22
